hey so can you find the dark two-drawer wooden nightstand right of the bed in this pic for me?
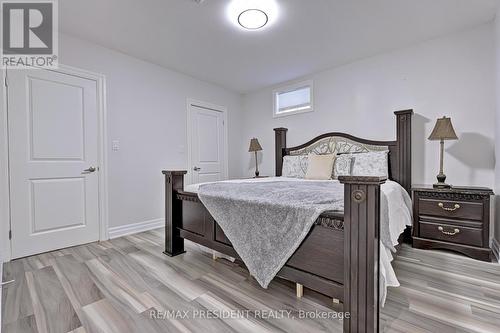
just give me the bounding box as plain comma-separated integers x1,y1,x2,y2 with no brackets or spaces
412,186,493,261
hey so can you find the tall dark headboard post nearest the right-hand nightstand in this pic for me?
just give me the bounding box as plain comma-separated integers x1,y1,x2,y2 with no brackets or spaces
392,110,413,192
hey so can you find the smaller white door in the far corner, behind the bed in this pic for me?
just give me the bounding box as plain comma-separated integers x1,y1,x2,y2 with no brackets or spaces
189,103,226,184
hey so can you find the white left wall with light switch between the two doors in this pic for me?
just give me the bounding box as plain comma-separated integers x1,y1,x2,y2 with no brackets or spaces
59,35,242,227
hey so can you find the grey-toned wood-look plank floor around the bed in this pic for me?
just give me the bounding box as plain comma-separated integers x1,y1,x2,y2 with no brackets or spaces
2,229,500,333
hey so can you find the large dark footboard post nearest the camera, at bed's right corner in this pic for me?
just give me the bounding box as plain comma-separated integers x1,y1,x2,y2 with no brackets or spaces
339,176,386,333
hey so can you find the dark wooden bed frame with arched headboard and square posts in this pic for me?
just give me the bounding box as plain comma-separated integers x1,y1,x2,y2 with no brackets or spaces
163,110,413,332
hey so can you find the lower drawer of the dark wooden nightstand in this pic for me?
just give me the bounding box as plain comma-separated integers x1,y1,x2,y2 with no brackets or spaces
419,221,483,246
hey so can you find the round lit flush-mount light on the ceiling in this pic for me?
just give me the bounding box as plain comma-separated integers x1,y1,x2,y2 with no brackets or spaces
227,0,278,31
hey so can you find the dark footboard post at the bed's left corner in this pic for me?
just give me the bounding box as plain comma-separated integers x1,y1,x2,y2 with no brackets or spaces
162,171,187,257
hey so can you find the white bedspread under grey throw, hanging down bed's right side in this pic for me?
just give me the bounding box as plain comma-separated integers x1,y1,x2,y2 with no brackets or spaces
184,177,412,305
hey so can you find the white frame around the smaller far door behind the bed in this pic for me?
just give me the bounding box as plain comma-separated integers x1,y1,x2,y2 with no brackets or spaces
186,98,229,184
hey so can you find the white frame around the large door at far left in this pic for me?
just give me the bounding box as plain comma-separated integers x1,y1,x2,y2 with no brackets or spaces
0,64,109,262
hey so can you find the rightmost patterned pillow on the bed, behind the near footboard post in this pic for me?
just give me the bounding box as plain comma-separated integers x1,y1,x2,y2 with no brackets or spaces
352,150,389,177
